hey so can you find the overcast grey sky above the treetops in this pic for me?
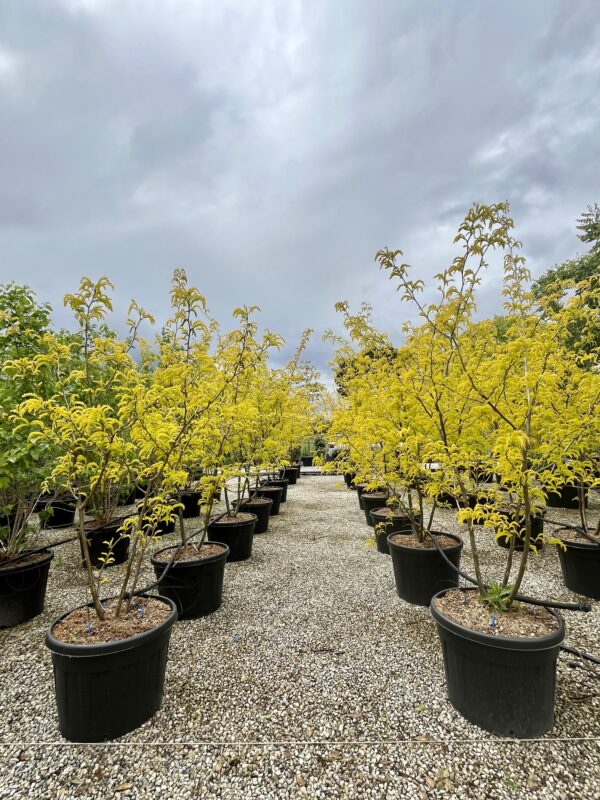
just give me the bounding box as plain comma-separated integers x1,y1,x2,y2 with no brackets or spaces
0,0,600,376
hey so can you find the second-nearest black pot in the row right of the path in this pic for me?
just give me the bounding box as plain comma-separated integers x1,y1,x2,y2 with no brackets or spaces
388,531,463,606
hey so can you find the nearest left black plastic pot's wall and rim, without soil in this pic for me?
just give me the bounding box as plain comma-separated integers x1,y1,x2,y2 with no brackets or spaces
46,597,177,742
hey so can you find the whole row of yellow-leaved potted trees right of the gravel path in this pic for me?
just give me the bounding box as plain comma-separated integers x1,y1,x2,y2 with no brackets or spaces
330,203,600,737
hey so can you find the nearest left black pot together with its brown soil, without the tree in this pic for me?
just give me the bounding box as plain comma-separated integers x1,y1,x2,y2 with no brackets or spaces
46,597,177,742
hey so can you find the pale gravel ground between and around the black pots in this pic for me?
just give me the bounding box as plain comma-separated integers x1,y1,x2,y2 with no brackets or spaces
0,476,600,800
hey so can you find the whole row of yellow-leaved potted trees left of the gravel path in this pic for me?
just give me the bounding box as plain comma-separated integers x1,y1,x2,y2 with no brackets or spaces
0,270,318,741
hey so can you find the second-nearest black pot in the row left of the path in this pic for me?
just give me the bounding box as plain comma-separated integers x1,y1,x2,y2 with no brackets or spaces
150,542,229,619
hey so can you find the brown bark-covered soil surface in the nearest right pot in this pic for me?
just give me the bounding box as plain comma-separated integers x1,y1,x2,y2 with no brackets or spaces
435,589,558,638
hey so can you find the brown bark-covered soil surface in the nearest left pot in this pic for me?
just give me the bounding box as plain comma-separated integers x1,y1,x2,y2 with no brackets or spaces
52,597,171,644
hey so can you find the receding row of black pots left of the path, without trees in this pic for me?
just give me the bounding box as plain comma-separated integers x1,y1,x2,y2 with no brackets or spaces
0,467,300,742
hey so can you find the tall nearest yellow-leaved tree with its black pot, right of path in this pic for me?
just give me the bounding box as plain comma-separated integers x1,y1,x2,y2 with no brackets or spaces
377,203,578,737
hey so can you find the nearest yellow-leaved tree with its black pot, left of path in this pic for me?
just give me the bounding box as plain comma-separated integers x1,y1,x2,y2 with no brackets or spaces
19,278,177,741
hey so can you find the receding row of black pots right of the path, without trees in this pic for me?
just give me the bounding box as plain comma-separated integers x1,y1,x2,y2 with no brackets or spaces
345,475,600,738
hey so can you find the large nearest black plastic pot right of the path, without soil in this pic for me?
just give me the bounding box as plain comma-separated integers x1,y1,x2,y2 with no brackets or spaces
431,589,565,739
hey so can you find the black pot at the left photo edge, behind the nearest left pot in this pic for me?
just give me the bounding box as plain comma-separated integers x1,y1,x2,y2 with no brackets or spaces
0,550,54,628
